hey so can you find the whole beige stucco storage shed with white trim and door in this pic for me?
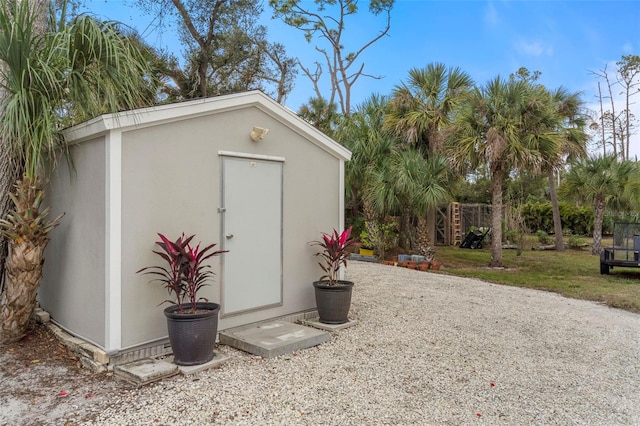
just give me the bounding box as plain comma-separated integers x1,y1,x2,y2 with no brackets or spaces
39,91,351,362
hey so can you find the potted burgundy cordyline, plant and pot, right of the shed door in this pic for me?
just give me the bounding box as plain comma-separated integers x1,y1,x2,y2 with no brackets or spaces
309,227,360,324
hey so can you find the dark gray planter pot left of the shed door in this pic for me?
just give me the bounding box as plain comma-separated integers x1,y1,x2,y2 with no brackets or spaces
164,302,220,365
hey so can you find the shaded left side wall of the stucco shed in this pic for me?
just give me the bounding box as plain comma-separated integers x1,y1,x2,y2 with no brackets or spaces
38,137,107,347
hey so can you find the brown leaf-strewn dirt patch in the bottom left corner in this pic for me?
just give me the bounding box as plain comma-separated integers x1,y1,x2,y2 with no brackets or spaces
0,323,134,425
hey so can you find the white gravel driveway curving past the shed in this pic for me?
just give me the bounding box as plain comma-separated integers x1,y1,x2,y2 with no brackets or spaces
84,261,640,425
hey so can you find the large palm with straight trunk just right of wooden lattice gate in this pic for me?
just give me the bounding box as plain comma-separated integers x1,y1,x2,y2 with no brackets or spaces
447,77,552,267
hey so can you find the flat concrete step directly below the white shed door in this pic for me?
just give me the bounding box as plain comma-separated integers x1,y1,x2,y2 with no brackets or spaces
219,321,330,358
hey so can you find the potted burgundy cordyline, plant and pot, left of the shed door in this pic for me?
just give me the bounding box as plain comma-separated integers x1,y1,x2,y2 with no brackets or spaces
138,233,227,365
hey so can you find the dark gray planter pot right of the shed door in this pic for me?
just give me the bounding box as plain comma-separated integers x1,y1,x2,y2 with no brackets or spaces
313,280,353,324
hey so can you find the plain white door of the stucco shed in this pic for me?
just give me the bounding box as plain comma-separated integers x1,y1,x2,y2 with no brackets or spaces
222,156,282,315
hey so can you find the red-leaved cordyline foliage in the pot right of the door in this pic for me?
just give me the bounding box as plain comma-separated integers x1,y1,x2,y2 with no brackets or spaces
309,226,361,285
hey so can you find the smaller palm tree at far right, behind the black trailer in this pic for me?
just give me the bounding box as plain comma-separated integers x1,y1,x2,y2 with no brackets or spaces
560,154,640,254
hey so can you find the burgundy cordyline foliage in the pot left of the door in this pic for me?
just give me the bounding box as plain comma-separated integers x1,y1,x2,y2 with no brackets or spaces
138,233,228,312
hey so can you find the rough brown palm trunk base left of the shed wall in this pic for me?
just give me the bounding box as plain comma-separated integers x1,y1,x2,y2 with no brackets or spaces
0,241,46,343
